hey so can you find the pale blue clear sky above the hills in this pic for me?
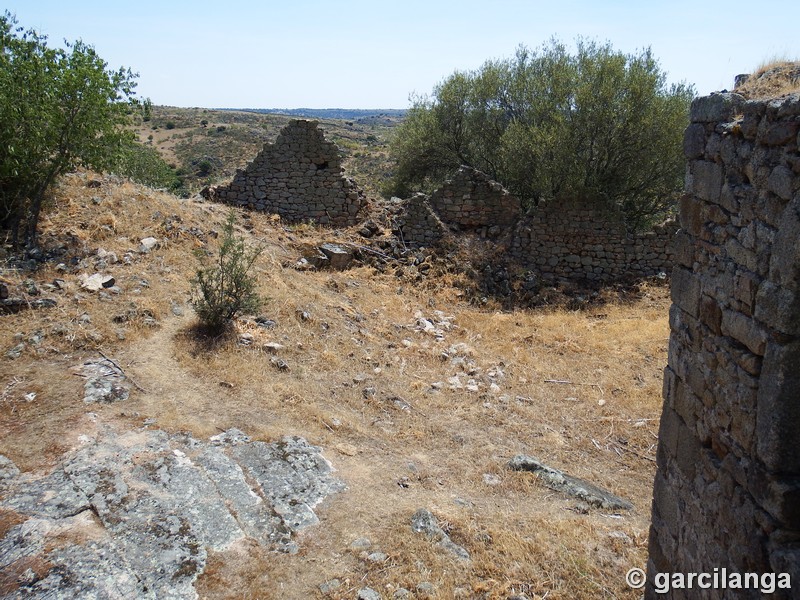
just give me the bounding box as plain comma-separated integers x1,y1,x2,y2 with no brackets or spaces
6,0,800,109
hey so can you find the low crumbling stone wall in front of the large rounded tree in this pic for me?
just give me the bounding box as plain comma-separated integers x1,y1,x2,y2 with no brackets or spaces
399,167,677,282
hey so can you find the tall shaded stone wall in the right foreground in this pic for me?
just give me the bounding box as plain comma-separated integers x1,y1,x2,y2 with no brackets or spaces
645,94,800,599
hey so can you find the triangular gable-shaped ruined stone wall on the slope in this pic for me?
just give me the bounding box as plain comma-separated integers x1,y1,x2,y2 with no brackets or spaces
214,119,366,226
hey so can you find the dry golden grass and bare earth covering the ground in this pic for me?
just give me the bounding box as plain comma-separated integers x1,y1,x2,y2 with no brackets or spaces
0,174,668,599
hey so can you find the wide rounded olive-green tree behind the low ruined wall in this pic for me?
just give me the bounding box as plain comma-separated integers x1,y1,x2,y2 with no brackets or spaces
387,40,694,228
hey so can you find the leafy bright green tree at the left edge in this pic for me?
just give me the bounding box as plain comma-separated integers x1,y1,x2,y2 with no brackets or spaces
0,12,135,248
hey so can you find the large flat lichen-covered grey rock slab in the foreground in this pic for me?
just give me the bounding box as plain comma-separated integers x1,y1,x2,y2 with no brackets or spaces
0,429,345,599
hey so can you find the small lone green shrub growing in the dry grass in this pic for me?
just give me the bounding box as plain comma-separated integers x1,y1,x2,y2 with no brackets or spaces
192,210,263,335
